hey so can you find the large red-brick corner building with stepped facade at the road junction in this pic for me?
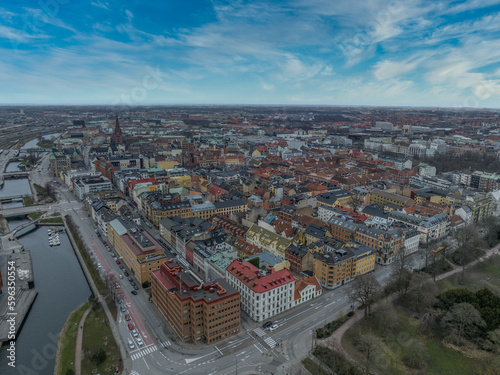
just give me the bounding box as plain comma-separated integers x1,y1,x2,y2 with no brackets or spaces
151,259,240,344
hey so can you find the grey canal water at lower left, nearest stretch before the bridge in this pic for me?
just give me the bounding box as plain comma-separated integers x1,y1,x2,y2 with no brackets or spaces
0,219,91,375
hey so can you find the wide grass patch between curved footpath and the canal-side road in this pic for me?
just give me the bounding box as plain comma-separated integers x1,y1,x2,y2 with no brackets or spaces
82,307,121,375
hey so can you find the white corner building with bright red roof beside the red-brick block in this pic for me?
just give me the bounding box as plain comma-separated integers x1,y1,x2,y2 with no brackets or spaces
226,259,295,322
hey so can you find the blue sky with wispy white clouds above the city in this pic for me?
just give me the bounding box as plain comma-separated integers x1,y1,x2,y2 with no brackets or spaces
0,0,500,108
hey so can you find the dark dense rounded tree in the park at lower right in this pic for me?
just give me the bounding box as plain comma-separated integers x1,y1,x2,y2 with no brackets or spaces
442,302,486,345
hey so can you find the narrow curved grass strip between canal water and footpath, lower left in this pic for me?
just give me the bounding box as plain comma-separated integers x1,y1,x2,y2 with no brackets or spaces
55,302,90,375
